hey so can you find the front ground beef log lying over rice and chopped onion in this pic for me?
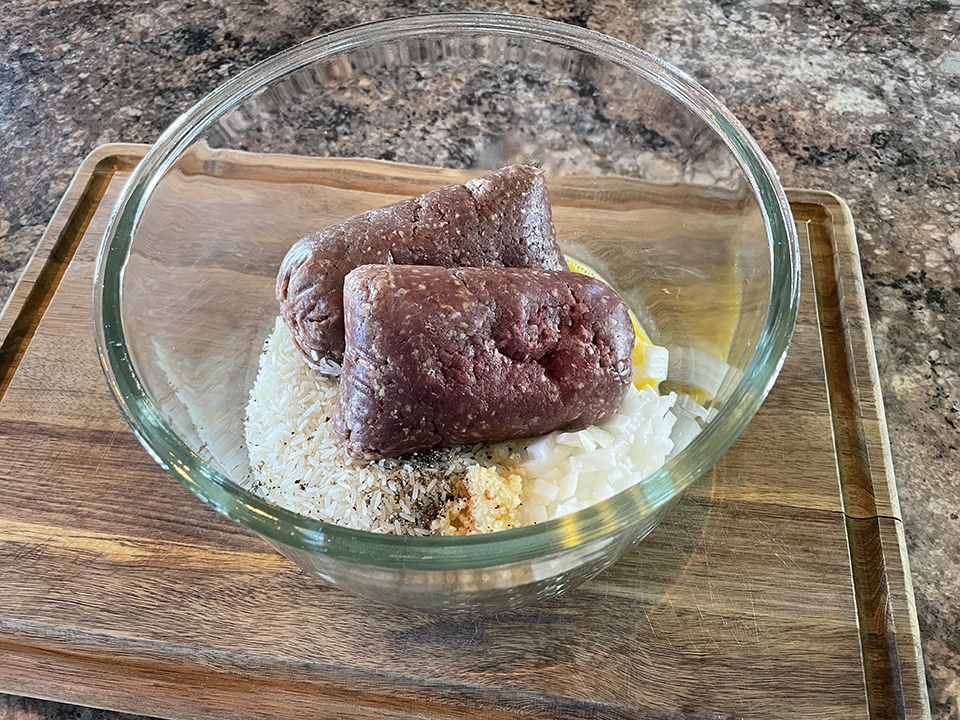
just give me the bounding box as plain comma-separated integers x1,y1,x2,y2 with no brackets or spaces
334,265,634,459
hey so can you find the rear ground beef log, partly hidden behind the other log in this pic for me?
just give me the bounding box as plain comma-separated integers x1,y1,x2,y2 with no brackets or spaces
277,165,566,366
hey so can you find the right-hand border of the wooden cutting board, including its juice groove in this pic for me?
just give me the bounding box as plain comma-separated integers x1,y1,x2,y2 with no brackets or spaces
787,189,930,720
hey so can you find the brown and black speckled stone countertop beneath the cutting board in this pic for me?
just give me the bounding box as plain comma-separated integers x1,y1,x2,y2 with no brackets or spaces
0,0,960,720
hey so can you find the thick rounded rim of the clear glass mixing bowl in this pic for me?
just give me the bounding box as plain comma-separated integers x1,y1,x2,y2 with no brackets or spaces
94,13,800,570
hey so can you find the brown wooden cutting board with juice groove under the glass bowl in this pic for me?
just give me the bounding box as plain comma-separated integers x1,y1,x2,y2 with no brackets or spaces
0,145,929,720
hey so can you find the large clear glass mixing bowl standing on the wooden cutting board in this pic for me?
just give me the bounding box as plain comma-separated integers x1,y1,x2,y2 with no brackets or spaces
95,14,799,612
